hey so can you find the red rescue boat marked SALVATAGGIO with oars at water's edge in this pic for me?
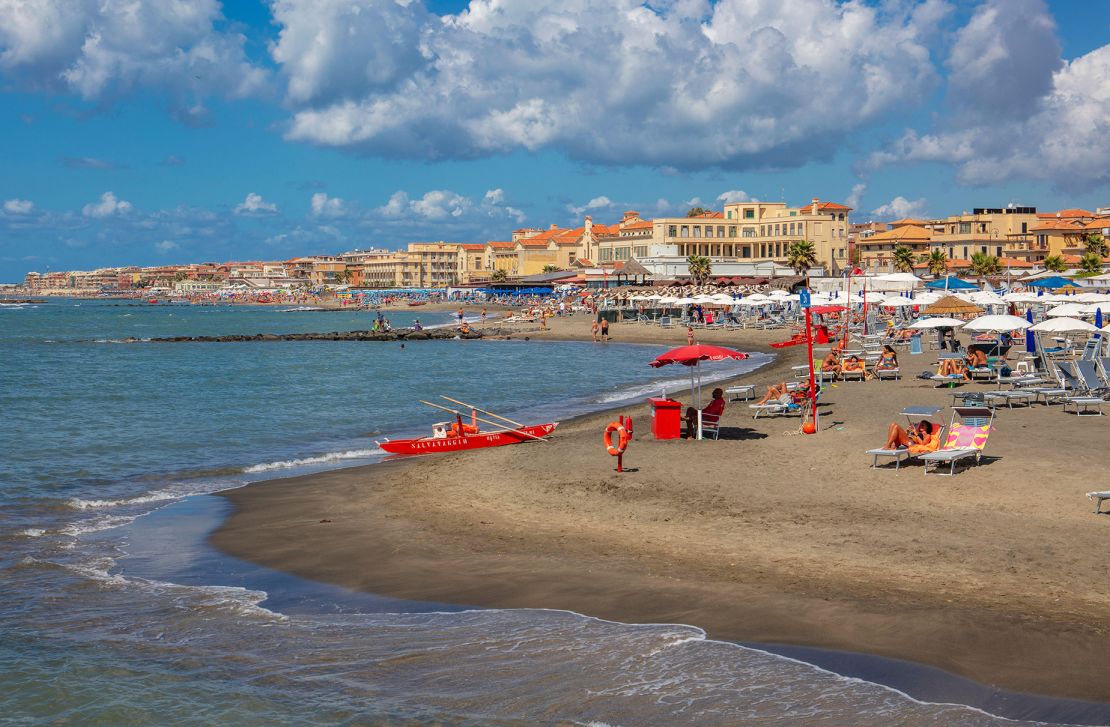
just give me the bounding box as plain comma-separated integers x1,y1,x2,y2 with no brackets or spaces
376,396,558,454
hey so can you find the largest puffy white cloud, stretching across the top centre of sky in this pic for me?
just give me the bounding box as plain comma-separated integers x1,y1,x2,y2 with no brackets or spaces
271,0,947,170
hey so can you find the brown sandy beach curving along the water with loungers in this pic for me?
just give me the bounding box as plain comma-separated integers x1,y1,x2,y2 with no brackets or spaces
212,316,1110,701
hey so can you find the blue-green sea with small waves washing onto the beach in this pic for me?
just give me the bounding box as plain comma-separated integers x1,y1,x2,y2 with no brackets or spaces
0,300,1110,727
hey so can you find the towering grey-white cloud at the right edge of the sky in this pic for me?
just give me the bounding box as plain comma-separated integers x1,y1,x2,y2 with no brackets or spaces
867,0,1110,191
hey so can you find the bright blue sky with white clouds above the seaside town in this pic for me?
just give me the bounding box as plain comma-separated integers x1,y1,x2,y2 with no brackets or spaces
0,0,1110,282
